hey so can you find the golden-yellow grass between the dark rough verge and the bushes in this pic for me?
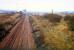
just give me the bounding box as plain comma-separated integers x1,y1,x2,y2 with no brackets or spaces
32,17,72,50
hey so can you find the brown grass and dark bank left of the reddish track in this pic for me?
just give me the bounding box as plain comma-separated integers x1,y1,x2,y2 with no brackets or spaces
0,14,20,41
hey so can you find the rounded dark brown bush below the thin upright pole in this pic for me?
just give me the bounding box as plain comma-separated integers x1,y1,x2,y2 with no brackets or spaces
44,14,62,23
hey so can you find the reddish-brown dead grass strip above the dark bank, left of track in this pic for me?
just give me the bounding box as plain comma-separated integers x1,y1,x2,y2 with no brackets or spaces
0,14,19,24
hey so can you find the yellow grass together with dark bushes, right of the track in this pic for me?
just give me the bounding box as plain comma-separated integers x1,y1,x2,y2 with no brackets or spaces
32,15,74,50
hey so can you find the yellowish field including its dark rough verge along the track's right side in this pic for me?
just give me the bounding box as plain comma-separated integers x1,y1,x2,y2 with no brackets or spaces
31,16,74,50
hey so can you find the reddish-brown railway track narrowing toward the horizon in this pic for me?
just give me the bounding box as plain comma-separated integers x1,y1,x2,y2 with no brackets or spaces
0,15,35,50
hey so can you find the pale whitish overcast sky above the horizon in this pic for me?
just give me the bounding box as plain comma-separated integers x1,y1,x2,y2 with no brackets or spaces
0,0,74,12
